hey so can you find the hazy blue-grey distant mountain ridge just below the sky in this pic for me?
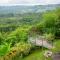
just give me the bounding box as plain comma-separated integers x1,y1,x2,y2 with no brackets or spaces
0,4,60,14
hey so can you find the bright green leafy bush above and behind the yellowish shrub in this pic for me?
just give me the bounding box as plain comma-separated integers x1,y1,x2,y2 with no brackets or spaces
6,29,28,45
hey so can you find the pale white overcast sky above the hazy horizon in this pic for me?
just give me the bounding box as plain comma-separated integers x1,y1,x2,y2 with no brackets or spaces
0,0,60,6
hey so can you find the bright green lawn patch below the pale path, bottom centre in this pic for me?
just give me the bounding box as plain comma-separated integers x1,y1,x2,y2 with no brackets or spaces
22,49,51,60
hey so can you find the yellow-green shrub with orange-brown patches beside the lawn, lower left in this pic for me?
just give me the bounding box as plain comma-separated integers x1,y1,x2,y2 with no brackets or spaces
4,42,31,60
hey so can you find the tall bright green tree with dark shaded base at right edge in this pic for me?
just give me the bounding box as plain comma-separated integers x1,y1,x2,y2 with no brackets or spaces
37,9,60,37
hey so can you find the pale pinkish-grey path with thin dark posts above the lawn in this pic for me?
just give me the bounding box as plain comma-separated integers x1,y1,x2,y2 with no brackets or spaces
29,37,53,49
